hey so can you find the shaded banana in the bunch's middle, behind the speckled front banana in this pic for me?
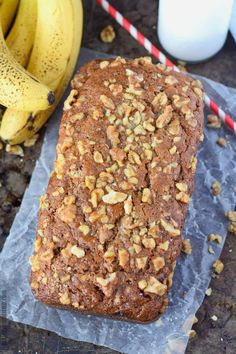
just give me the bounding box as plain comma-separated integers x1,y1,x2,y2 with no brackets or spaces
6,0,37,67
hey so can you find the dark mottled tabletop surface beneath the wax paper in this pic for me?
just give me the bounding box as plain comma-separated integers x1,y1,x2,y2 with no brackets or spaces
0,0,236,354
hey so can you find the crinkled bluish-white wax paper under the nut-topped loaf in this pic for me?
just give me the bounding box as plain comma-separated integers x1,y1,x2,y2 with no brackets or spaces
0,49,236,354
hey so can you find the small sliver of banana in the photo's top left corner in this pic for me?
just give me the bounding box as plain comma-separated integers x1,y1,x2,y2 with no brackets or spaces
0,0,19,35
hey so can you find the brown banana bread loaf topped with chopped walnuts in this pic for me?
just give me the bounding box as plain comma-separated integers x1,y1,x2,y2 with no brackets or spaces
30,58,203,322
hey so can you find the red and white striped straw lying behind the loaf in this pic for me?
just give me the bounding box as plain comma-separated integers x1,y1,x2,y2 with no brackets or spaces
96,0,236,134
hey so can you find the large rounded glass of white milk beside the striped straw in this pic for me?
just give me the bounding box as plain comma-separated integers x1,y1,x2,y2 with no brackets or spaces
157,0,233,62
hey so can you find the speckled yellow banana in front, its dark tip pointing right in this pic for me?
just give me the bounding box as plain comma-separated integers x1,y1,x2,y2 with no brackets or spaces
0,20,54,111
